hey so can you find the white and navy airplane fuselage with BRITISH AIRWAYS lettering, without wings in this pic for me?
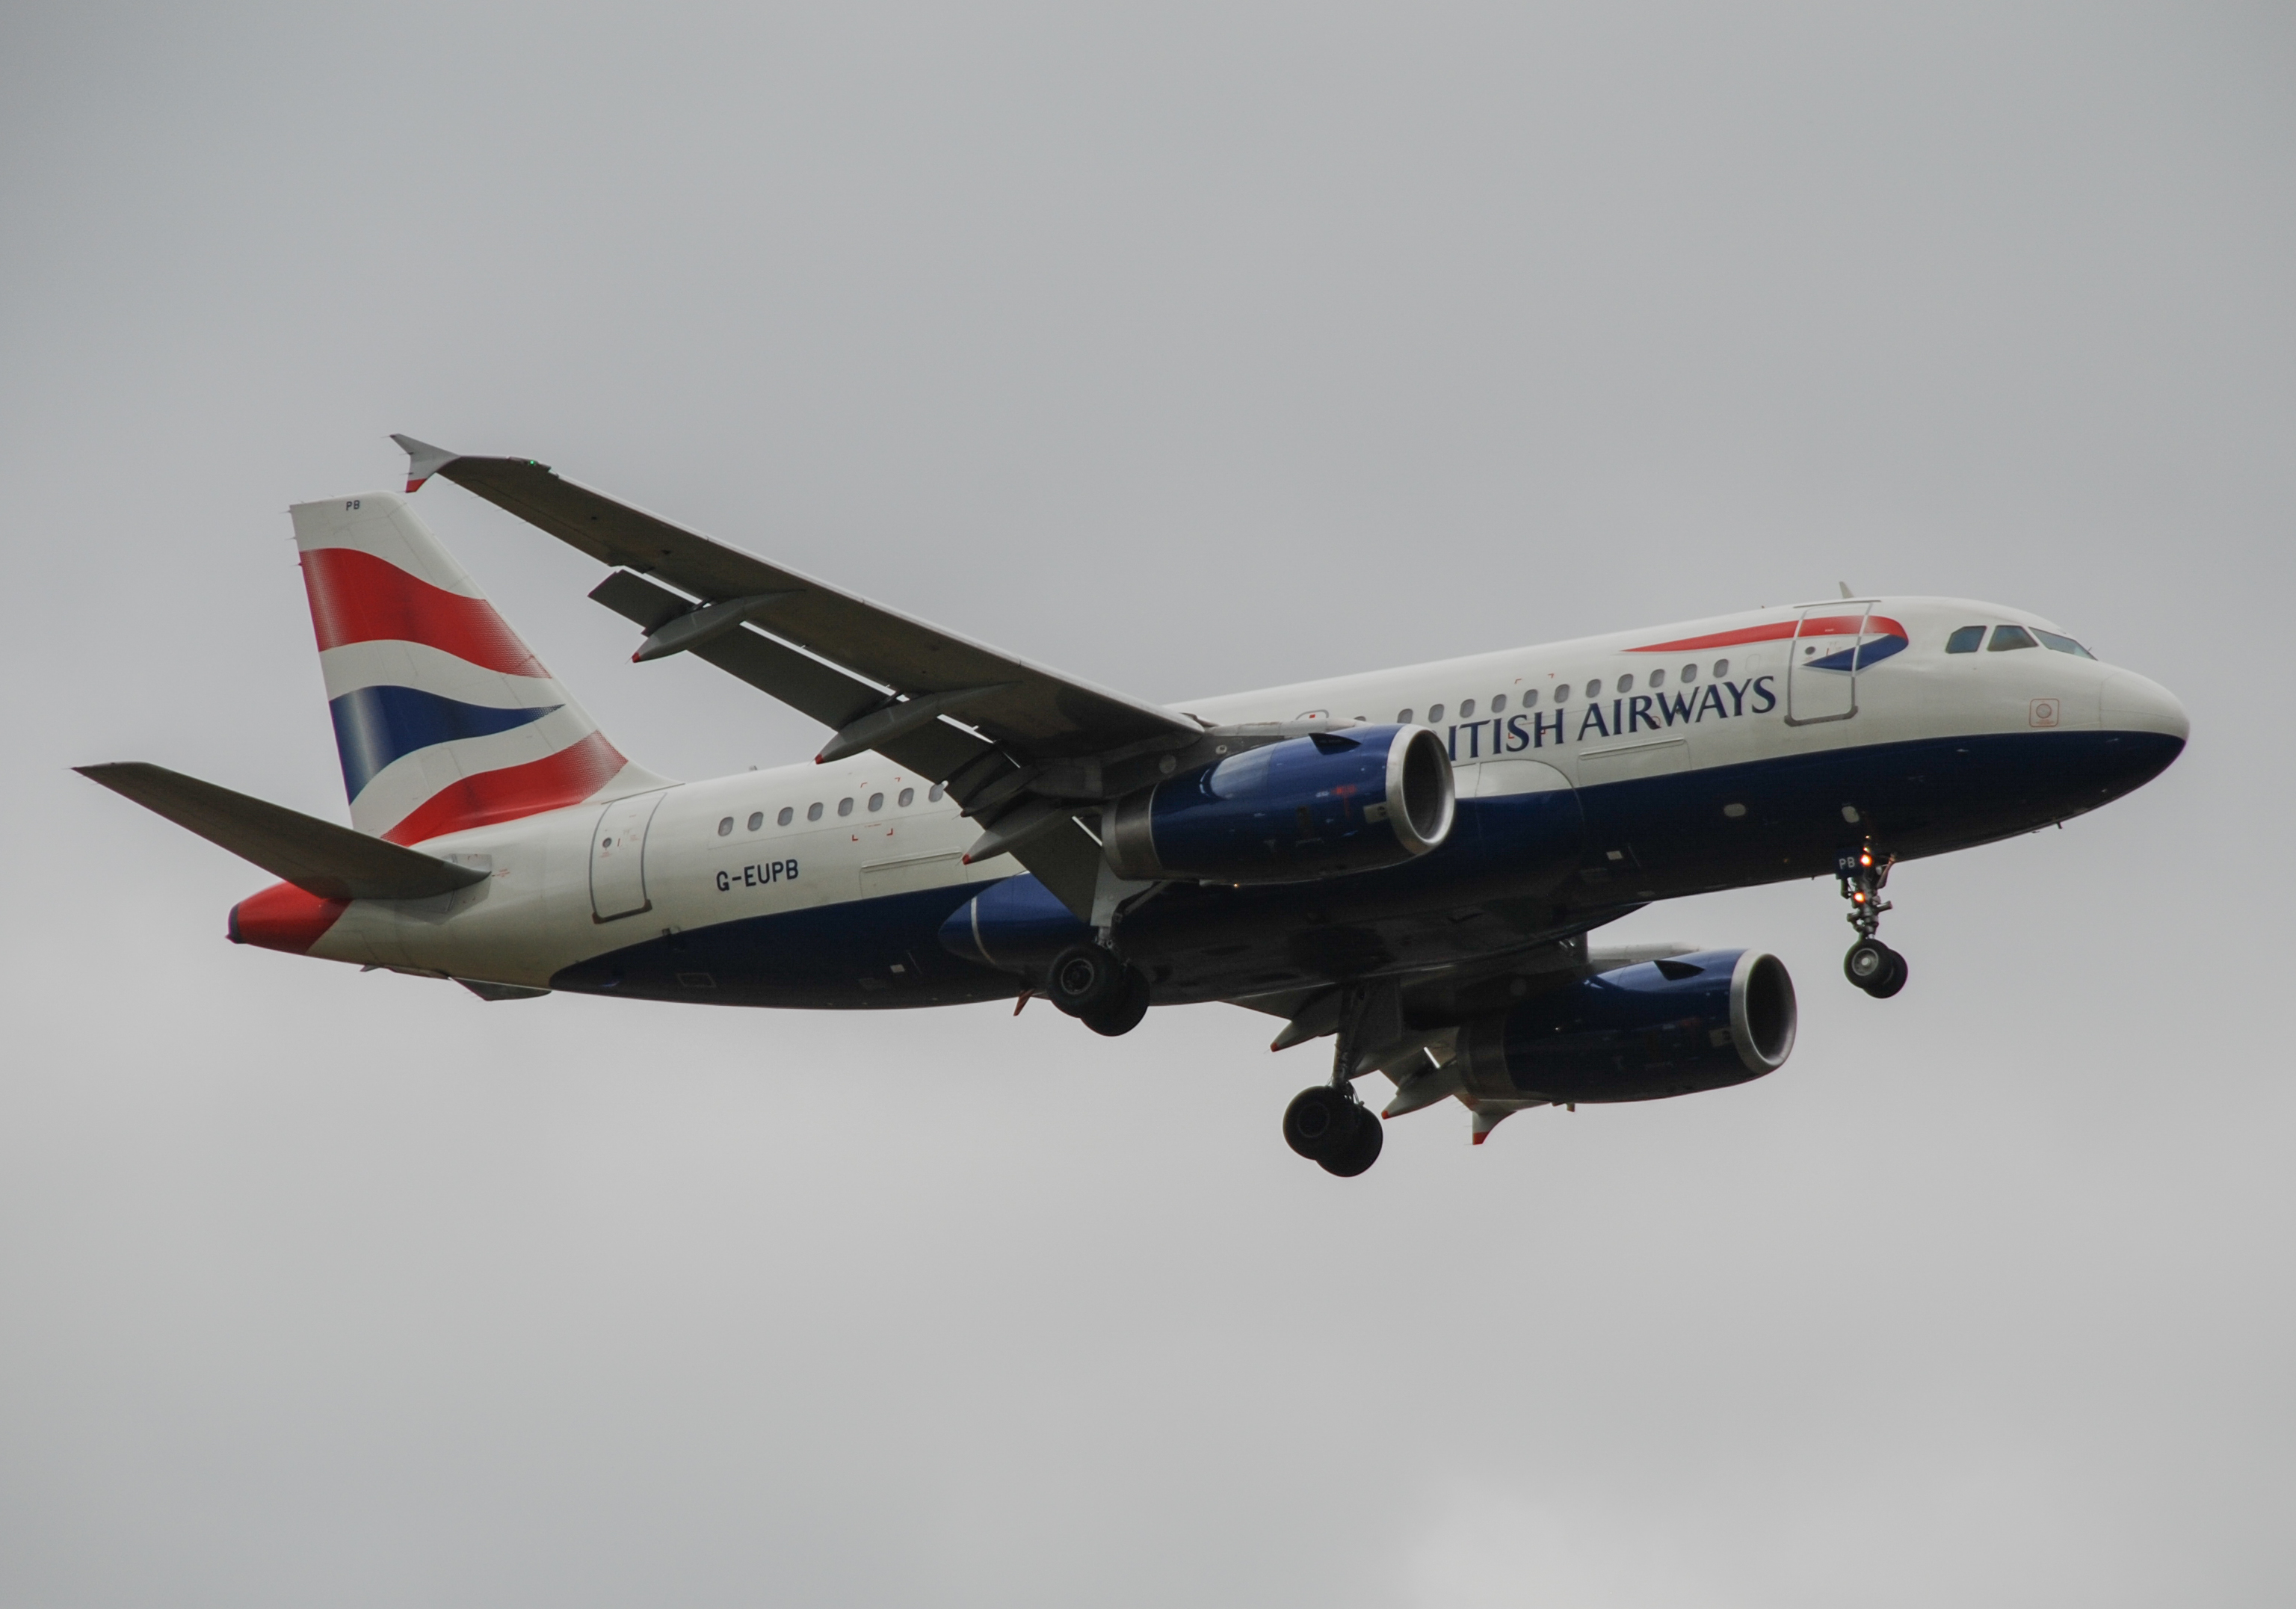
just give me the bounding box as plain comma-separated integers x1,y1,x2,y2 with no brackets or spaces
251,597,2186,1007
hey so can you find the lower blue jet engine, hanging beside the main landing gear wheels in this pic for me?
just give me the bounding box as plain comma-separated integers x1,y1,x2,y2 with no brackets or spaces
1460,951,1795,1104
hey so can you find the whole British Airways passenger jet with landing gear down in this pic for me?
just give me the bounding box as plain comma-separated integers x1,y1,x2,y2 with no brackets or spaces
83,436,2188,1178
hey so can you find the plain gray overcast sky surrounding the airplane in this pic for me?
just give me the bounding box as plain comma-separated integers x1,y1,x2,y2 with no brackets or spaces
0,2,2296,1609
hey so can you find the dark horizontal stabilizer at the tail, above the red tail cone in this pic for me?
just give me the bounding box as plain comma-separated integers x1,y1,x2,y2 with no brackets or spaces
73,760,487,900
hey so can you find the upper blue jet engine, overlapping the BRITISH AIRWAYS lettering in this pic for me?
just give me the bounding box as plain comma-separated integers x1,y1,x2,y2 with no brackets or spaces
1102,726,1458,883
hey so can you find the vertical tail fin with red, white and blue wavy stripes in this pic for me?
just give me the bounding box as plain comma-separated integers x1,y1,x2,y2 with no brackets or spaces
291,491,661,844
